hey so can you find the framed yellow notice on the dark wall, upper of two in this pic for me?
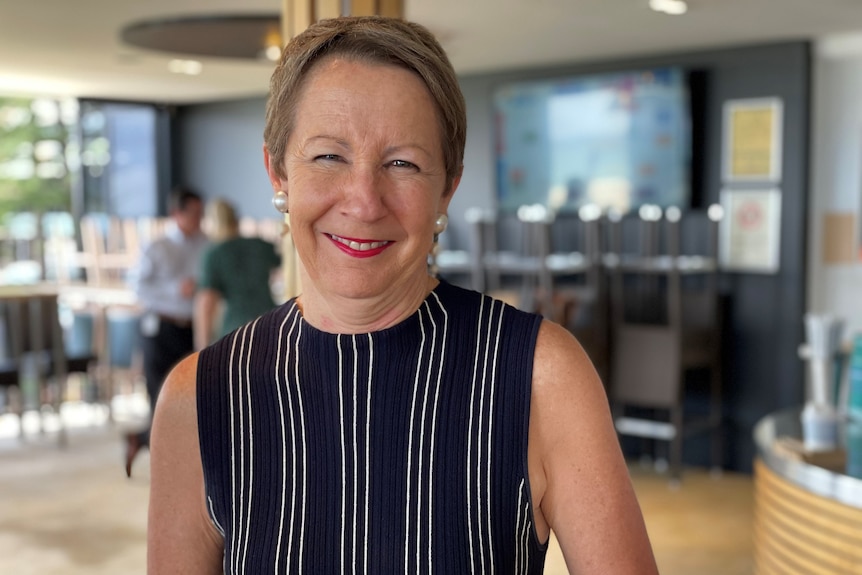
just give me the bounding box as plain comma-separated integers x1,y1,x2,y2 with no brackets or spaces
722,98,783,183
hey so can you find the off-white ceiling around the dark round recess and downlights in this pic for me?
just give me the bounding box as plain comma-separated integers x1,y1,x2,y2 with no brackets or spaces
0,0,862,103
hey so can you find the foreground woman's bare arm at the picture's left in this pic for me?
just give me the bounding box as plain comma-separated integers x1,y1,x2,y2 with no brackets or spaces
147,354,224,575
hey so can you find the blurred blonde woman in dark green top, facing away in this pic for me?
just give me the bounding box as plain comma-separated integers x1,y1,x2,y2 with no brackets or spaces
194,199,281,349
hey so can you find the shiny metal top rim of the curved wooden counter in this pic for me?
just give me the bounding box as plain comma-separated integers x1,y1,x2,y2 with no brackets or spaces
754,408,862,509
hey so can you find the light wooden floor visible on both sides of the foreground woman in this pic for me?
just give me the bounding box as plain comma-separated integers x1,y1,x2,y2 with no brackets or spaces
0,404,753,575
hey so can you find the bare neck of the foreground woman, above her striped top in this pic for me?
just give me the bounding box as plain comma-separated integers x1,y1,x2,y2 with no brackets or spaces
297,274,439,333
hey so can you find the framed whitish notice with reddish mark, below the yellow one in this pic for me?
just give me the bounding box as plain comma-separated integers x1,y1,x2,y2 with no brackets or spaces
719,189,781,273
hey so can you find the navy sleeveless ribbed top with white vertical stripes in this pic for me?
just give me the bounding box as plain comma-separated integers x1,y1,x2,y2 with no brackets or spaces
197,282,547,575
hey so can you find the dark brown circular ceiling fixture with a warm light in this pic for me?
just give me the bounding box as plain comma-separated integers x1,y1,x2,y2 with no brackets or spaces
120,14,281,60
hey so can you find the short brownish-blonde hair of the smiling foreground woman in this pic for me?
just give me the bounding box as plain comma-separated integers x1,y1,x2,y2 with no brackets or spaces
263,16,467,194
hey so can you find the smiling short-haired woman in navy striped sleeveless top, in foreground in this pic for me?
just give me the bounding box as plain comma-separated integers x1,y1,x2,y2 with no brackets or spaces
149,18,656,574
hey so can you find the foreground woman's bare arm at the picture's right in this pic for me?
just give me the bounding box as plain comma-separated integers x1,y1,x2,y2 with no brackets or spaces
528,321,658,575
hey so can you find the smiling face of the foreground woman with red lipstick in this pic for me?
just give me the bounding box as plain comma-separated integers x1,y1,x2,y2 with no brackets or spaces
268,58,457,298
